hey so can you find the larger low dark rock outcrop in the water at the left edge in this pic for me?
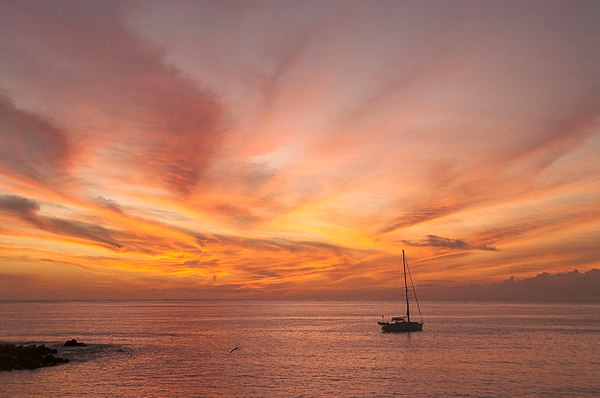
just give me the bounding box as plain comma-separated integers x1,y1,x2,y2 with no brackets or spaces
0,344,69,371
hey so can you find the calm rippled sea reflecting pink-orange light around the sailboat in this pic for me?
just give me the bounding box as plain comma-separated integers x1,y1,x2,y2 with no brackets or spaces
0,301,600,397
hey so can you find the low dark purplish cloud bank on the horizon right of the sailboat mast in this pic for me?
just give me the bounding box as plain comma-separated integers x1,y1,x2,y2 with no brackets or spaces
417,269,600,302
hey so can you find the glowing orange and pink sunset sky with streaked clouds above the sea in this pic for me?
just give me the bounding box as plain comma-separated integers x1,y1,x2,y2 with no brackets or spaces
0,0,600,299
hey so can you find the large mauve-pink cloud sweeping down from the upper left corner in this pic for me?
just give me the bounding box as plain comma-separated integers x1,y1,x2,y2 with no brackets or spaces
0,1,224,196
